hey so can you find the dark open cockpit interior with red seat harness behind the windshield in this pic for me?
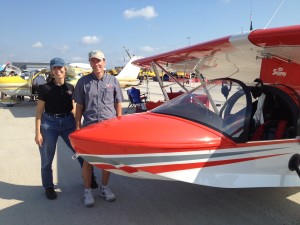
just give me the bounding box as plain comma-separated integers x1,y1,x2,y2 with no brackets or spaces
250,85,299,141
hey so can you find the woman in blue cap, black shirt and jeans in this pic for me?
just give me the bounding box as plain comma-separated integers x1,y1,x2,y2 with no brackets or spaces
35,58,97,199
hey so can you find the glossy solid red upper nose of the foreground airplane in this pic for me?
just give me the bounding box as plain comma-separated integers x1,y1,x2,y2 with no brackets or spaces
70,112,227,154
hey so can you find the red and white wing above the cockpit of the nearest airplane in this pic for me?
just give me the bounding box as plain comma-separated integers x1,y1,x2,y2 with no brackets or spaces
133,25,300,82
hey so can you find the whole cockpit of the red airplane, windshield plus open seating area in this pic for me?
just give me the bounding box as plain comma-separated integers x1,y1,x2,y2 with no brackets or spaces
152,78,300,143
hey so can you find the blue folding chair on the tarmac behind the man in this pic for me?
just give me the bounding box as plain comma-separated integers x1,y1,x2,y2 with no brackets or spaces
125,87,147,113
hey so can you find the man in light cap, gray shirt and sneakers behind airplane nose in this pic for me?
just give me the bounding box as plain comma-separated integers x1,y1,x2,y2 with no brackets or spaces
73,50,123,206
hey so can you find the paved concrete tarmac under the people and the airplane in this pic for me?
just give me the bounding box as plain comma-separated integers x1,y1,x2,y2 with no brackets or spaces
0,83,300,225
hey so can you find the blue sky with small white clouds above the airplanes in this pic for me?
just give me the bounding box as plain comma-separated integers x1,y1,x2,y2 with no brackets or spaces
0,0,300,68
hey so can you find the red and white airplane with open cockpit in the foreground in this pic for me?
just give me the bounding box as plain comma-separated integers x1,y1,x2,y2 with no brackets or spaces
70,25,300,188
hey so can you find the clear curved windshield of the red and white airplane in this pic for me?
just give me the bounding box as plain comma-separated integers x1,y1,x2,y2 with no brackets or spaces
152,79,251,140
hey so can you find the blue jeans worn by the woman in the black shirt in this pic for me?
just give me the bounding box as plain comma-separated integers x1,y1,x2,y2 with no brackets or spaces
39,113,83,188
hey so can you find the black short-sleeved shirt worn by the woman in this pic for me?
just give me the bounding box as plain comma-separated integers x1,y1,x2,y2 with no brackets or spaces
38,80,74,114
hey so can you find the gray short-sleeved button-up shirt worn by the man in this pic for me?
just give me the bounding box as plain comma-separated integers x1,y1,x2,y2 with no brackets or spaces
73,73,124,126
